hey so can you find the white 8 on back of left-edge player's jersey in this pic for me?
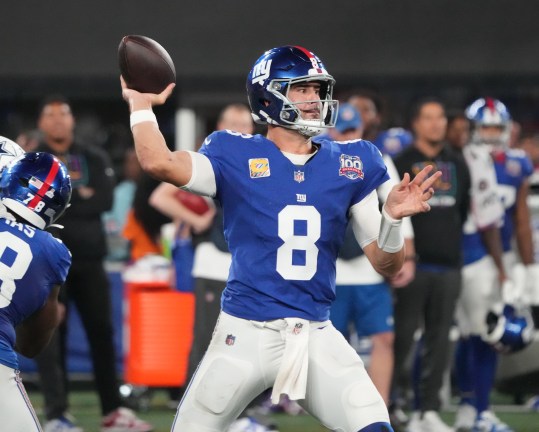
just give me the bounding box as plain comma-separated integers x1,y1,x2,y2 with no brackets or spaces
0,231,33,308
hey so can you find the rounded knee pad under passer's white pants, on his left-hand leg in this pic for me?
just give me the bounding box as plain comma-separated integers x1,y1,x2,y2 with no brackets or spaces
195,357,248,414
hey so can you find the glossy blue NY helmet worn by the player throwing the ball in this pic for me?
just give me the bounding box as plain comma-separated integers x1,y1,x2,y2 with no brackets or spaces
247,46,339,136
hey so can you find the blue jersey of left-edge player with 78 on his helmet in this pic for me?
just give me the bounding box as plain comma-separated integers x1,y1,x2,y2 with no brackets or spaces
0,219,71,369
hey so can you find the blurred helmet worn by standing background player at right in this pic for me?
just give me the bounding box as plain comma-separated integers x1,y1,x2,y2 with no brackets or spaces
466,98,511,146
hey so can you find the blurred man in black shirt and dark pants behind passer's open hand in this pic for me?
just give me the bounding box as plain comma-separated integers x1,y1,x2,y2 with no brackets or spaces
393,98,470,432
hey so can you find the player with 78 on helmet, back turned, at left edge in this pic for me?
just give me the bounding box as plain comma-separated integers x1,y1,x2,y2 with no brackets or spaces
0,148,71,432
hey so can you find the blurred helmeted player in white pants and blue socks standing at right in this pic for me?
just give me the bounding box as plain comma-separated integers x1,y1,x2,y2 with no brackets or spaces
455,98,535,432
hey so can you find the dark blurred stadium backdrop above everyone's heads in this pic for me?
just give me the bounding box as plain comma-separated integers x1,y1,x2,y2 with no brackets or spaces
0,0,539,431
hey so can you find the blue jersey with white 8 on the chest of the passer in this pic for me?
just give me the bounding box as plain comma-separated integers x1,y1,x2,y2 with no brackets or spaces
200,131,388,321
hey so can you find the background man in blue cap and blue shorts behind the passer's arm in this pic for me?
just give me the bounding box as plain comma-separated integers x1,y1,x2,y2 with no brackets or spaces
326,103,415,404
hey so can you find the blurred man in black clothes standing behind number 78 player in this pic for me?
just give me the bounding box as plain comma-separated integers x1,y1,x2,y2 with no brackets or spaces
33,96,152,432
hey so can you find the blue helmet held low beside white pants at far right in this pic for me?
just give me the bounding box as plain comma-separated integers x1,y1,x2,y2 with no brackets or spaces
482,304,534,353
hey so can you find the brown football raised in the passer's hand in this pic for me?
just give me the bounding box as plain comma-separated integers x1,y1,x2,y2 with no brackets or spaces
118,35,176,93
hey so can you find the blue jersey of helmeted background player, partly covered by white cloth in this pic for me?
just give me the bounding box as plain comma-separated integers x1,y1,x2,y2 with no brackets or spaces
462,149,533,264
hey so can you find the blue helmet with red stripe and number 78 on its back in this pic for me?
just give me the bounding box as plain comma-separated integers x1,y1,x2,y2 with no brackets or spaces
0,152,71,229
